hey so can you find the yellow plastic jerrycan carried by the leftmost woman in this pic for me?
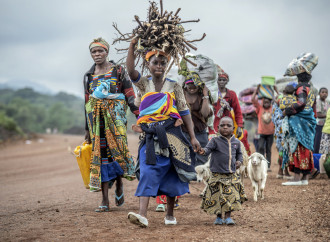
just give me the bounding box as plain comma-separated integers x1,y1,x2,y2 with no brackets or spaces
73,141,92,189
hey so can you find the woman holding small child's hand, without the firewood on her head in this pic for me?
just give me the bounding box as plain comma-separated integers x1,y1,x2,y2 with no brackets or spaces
126,39,200,227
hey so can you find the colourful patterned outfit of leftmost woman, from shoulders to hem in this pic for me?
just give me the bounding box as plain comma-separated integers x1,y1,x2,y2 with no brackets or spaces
85,67,137,190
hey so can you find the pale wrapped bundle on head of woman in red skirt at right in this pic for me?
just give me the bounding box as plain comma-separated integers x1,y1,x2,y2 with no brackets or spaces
284,53,319,76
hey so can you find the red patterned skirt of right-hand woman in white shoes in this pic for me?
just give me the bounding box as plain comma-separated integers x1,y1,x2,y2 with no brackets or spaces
289,143,314,174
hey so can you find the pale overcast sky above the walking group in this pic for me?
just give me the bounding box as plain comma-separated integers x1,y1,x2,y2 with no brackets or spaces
0,0,330,96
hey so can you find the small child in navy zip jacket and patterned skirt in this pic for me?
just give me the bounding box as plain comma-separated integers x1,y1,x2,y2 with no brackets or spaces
200,117,247,225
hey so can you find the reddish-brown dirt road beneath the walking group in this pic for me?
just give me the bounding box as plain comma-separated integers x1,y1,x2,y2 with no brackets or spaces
0,135,330,241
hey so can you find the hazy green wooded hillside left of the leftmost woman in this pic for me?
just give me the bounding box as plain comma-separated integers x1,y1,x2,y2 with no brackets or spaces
0,88,85,133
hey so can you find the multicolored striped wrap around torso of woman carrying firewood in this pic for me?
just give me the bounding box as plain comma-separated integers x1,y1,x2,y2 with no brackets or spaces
137,92,181,124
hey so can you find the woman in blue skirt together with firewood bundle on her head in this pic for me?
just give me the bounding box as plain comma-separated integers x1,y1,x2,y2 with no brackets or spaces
113,0,206,227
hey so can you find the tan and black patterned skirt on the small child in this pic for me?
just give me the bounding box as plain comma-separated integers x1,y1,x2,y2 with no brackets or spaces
201,172,247,215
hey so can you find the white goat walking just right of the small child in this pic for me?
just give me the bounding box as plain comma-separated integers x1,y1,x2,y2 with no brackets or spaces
247,152,268,201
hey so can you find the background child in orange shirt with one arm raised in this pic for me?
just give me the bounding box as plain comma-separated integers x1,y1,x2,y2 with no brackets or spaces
252,85,275,171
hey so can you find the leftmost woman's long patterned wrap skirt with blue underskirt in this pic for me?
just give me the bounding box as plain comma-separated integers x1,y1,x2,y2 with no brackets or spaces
85,97,135,190
